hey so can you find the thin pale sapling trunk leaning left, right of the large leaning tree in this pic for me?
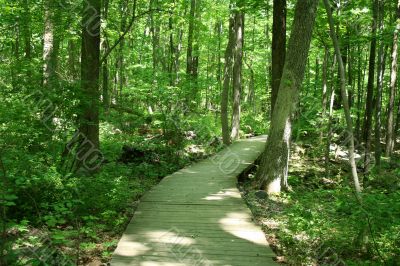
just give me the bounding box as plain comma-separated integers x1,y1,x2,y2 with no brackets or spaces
324,0,361,196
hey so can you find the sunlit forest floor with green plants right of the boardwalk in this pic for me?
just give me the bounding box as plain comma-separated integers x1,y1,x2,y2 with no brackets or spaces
239,143,400,265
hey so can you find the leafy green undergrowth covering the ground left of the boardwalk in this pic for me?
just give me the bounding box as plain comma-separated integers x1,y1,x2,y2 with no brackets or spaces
0,109,221,265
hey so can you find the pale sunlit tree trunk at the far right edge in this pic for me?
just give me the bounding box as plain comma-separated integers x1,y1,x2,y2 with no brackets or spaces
385,1,400,157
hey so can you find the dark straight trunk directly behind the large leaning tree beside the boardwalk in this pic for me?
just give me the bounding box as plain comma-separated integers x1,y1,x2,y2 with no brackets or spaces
271,0,286,115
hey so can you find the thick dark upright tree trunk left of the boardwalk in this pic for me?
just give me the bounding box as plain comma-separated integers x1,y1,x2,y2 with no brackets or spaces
75,0,101,172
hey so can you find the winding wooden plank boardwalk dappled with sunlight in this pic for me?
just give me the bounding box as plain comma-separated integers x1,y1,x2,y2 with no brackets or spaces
111,137,277,266
